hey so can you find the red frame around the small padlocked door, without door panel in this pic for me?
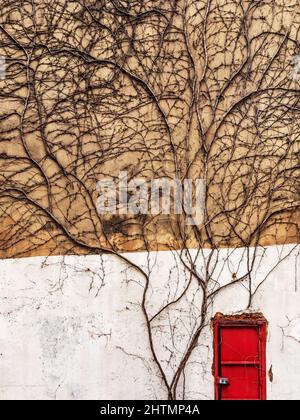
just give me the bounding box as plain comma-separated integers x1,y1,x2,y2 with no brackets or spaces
214,317,268,401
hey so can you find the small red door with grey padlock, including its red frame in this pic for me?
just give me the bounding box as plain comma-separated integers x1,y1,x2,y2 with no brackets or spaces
214,320,266,400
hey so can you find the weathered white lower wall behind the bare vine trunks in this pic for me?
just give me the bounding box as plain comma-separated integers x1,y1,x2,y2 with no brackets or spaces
0,246,300,399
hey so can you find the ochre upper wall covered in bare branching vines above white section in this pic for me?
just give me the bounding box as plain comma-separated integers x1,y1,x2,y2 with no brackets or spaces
0,0,300,258
